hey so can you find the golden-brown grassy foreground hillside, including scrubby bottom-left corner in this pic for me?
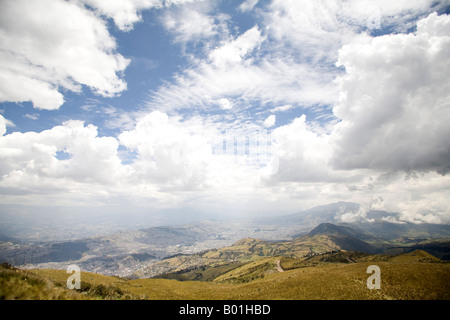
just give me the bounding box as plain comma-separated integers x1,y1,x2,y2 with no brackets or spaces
0,251,450,300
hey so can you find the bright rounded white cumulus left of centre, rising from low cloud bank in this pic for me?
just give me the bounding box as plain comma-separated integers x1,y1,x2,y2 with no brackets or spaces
119,111,212,189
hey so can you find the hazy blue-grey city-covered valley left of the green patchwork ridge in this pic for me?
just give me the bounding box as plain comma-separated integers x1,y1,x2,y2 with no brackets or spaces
0,221,296,277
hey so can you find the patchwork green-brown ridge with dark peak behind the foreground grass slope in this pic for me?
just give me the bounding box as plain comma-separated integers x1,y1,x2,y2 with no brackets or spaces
139,223,450,280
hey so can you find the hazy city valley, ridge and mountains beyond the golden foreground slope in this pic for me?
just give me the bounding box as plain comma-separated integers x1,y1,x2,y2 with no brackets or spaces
0,202,450,278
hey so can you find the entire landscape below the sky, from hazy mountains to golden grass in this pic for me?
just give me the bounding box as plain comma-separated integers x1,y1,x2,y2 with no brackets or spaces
0,203,450,299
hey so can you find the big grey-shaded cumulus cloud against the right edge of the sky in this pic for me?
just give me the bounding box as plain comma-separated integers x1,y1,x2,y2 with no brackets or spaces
333,14,450,174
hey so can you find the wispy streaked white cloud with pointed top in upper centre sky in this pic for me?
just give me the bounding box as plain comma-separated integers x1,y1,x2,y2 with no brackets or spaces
148,26,337,111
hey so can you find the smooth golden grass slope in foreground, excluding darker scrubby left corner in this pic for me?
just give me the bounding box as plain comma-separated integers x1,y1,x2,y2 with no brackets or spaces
22,252,450,300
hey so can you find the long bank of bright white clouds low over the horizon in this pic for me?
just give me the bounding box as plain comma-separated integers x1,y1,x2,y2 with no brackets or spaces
0,106,450,222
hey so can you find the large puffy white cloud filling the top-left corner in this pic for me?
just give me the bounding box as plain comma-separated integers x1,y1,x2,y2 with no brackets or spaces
0,0,129,109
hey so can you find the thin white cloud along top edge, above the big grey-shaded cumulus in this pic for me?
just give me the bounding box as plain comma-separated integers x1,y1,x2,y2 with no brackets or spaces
264,0,446,63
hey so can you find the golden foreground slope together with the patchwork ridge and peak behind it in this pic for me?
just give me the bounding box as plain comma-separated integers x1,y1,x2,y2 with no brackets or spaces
0,223,450,300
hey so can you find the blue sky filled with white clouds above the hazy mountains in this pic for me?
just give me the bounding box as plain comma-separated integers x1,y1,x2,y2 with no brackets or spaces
0,0,450,230
